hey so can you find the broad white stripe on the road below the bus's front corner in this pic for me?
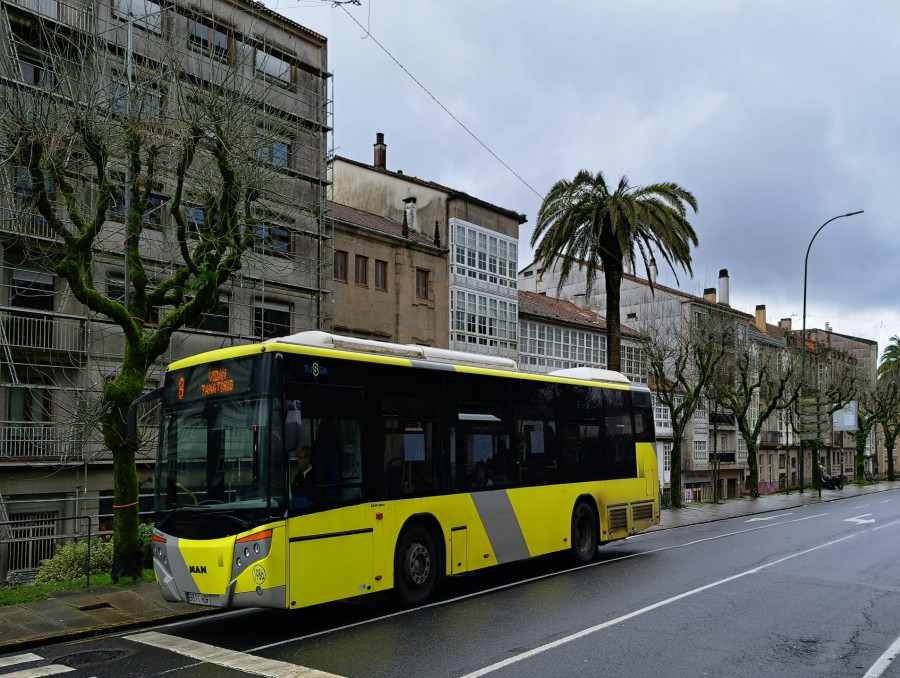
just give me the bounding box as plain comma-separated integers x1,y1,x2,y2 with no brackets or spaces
125,631,340,678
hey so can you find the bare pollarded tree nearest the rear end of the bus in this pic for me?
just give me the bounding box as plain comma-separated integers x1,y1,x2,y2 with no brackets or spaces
641,316,732,507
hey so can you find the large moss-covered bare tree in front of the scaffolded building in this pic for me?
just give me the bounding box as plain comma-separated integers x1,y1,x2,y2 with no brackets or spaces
0,10,294,579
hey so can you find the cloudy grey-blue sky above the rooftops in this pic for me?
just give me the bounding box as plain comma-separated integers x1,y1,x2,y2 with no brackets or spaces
278,0,900,358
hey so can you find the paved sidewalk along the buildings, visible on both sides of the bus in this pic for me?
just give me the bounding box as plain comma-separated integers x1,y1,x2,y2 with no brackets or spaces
0,481,900,654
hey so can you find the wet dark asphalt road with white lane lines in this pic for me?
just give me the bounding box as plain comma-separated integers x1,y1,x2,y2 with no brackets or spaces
0,490,900,678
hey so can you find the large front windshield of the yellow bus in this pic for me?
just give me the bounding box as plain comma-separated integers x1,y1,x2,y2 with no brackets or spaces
156,397,287,537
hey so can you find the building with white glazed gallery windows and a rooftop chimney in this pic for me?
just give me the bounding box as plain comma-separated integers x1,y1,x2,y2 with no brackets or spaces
332,133,526,360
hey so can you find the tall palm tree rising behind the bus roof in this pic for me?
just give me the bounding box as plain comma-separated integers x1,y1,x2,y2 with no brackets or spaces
531,170,697,370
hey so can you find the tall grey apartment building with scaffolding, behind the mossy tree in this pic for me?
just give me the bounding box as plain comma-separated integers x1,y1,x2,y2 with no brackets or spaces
0,0,333,576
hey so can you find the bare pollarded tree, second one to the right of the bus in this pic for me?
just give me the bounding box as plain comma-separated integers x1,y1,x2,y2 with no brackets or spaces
710,339,799,497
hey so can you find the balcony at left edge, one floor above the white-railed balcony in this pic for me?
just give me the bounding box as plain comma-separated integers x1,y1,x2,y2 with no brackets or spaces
0,306,86,363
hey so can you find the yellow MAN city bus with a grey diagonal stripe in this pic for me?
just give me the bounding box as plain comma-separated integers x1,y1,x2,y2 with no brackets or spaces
144,331,659,609
